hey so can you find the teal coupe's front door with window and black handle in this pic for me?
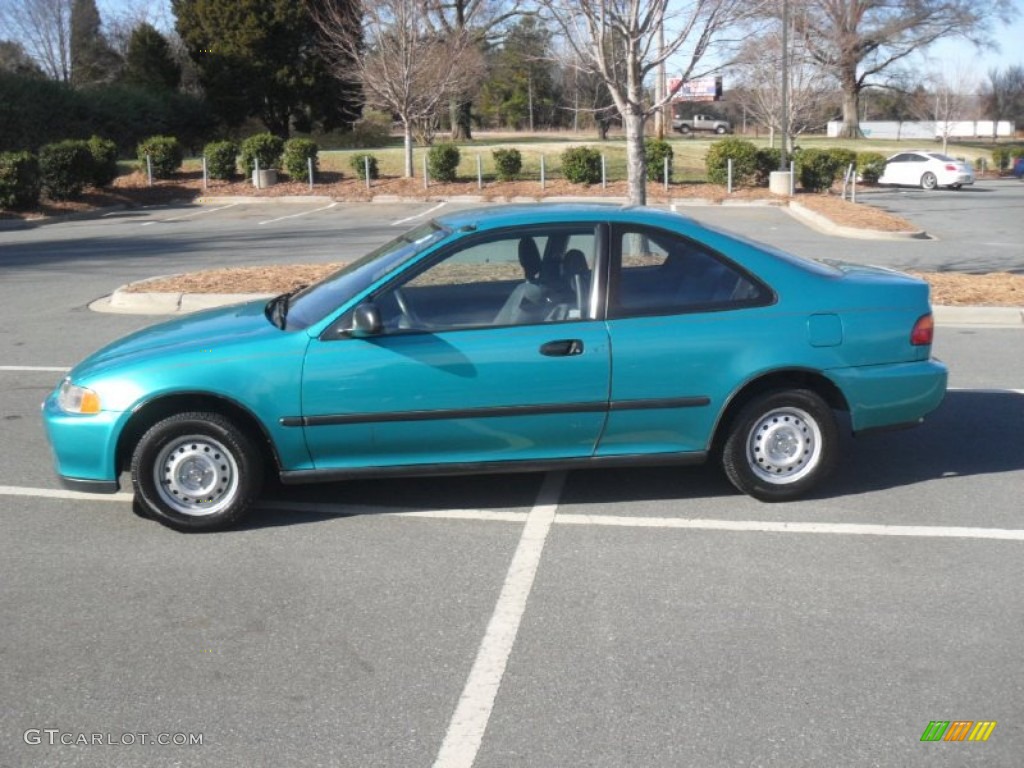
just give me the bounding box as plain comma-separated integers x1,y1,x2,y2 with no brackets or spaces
302,225,609,470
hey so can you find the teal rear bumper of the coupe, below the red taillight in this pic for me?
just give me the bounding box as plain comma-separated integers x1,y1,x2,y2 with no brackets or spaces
828,359,949,433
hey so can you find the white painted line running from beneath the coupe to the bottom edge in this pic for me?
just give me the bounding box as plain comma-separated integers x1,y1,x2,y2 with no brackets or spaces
434,472,565,768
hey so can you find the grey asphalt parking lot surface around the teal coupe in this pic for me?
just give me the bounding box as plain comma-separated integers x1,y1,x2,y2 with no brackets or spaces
0,195,1024,768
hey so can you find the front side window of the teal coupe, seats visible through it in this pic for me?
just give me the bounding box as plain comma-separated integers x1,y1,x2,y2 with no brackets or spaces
375,227,597,333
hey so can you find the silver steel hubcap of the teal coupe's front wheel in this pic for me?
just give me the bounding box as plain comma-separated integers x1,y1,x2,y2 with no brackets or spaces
153,435,239,516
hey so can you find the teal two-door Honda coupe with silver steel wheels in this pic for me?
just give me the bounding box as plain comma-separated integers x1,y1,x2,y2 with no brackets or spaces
43,205,946,530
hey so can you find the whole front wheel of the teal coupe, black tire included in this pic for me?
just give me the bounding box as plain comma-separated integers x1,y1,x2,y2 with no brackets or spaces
131,413,263,531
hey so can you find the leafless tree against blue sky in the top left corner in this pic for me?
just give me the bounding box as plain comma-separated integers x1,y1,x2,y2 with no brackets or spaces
0,0,72,83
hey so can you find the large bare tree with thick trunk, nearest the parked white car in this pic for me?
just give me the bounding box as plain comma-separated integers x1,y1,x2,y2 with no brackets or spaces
790,0,1014,138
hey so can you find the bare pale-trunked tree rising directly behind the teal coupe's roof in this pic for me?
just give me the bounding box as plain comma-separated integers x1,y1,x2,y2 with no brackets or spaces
539,0,751,205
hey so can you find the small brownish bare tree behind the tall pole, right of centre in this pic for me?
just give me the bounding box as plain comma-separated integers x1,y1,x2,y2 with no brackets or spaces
736,28,836,156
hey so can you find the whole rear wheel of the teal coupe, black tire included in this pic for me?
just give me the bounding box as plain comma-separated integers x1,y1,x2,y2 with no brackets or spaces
722,389,839,502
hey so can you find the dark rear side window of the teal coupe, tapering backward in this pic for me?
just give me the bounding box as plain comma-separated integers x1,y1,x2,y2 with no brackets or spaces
608,229,770,317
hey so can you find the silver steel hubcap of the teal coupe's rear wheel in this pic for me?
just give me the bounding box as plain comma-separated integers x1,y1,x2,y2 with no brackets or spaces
746,408,821,485
